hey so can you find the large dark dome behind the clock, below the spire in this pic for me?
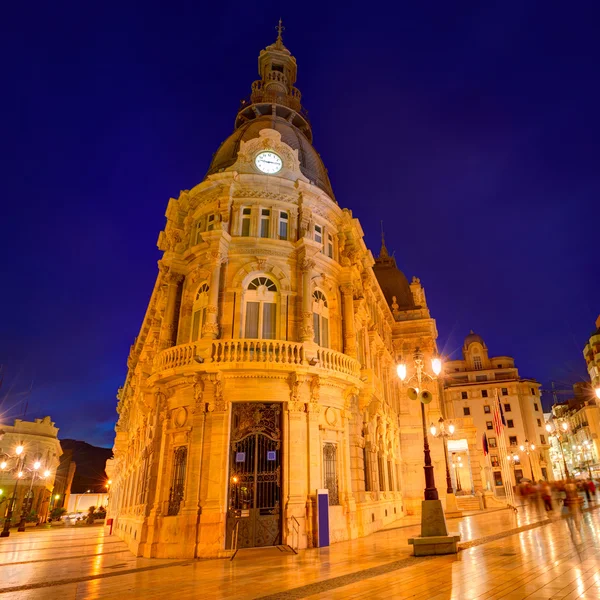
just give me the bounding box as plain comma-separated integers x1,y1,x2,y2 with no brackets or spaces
207,114,335,201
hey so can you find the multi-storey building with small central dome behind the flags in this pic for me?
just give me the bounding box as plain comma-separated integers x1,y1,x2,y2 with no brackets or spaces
444,331,552,495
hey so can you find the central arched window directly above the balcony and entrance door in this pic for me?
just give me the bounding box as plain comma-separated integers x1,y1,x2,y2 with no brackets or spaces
244,275,277,340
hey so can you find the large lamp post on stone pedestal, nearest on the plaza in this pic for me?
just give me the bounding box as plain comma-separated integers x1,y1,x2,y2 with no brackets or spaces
397,348,460,556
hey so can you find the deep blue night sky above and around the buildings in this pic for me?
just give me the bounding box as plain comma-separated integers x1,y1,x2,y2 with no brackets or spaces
0,0,600,446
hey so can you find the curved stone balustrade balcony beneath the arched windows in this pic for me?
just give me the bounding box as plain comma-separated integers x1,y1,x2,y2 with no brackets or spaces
154,339,360,379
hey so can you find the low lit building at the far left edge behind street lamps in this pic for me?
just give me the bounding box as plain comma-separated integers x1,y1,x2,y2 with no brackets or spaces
0,417,62,523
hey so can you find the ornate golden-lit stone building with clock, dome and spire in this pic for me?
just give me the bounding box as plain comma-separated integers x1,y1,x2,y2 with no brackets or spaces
108,28,444,557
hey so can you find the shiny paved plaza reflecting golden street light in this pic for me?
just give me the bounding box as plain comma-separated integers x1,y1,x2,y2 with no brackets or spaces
0,508,600,600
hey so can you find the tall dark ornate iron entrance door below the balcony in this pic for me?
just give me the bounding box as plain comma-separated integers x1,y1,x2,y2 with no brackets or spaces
226,402,281,548
